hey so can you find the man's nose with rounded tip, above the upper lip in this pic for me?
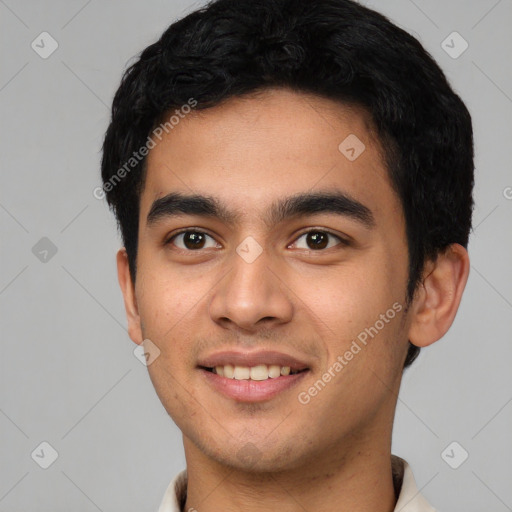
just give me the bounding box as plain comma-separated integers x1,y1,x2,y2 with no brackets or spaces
209,242,293,331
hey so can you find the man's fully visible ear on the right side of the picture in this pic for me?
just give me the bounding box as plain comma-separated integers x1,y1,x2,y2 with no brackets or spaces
409,244,469,347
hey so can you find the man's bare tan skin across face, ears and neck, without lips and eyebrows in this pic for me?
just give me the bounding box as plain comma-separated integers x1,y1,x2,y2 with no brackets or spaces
117,89,469,512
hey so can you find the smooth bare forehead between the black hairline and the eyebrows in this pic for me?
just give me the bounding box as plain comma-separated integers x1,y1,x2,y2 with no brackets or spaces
141,89,399,226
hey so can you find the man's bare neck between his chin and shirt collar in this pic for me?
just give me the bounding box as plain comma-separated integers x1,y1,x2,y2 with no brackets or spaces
184,439,396,512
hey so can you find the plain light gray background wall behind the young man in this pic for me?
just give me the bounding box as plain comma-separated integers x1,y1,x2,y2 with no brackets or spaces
0,0,512,512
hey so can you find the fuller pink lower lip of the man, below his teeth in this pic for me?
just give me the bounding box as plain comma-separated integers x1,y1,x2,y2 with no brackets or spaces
200,368,309,402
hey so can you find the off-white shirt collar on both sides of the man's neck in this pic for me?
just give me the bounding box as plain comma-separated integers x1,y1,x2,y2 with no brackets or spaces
158,455,436,512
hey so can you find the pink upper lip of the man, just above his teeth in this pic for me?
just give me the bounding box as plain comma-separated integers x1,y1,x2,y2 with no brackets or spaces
198,350,309,370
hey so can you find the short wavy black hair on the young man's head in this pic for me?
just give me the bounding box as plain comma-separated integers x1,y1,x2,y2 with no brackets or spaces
101,0,474,368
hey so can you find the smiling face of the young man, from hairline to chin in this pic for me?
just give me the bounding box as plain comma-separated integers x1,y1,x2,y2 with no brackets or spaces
123,89,408,471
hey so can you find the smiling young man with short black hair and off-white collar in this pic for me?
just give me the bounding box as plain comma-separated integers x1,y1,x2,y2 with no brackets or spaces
102,0,473,512
